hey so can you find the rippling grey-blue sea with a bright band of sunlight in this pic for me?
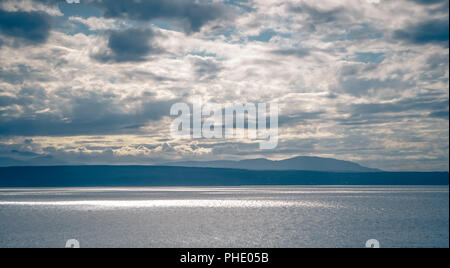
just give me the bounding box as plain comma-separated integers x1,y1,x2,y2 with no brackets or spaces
0,186,449,248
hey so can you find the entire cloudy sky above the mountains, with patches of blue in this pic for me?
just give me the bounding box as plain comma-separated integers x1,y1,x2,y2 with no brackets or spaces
0,0,449,171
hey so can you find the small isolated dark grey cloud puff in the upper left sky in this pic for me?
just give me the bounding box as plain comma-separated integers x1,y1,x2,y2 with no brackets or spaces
93,29,164,63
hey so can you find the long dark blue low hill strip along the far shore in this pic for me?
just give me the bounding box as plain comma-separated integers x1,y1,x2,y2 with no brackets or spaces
0,166,449,187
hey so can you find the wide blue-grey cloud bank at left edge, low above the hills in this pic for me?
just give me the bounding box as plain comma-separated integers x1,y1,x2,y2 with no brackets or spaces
0,89,178,136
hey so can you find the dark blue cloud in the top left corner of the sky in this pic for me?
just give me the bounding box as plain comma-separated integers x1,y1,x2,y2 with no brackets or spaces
0,9,51,46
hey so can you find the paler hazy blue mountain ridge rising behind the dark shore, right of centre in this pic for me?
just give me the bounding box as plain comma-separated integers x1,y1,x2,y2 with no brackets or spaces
164,156,381,173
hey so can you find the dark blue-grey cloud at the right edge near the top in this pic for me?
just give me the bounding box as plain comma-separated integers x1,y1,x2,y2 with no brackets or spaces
394,17,449,47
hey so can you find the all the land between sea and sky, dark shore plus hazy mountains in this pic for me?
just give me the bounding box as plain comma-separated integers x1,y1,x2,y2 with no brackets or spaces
0,156,449,187
